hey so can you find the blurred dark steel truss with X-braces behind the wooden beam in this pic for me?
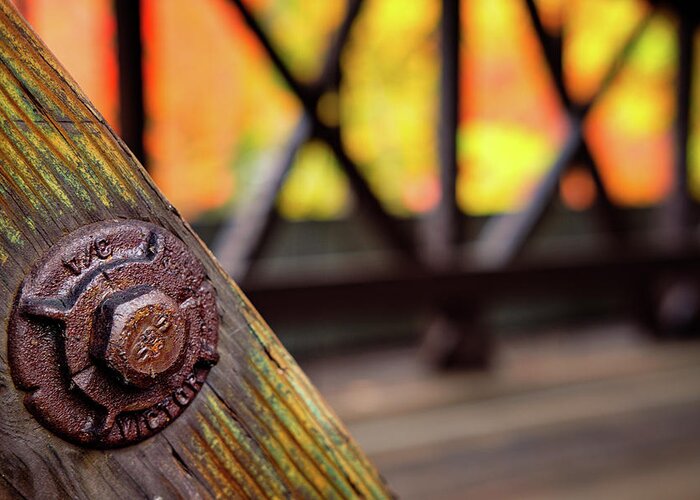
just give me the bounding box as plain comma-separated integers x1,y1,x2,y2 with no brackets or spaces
115,0,700,366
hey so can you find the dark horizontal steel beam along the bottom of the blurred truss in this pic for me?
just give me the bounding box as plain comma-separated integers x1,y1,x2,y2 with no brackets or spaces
244,248,700,317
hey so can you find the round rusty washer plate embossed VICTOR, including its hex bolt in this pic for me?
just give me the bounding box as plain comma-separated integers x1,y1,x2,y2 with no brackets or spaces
8,221,219,447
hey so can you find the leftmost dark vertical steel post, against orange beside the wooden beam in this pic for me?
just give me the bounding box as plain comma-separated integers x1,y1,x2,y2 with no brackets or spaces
114,0,147,166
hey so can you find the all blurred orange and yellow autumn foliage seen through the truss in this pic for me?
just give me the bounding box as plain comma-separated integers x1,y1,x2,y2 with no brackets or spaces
22,0,684,219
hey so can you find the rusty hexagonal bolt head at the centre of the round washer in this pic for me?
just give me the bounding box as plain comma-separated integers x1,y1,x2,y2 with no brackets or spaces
92,285,187,389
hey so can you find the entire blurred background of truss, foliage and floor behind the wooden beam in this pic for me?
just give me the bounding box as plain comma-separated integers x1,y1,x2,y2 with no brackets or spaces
16,0,700,498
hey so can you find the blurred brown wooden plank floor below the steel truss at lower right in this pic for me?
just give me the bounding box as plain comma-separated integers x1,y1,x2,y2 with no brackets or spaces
304,324,700,499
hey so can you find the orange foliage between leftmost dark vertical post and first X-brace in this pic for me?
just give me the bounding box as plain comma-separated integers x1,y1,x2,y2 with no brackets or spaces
143,0,295,218
